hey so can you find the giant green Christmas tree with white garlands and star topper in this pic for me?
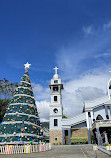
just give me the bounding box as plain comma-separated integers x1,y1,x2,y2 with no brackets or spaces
0,63,43,144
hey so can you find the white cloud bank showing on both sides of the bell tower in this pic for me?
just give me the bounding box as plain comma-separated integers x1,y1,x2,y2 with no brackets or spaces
32,70,109,121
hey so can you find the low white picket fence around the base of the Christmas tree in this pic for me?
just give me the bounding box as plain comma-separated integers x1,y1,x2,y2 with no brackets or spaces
0,143,51,154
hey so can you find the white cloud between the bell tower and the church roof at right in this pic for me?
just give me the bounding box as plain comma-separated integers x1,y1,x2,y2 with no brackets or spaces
62,72,109,117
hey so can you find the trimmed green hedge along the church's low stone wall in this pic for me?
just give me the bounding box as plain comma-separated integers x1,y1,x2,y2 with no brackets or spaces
71,137,88,144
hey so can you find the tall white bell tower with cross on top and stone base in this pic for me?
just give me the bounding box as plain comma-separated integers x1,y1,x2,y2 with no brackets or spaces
49,67,63,144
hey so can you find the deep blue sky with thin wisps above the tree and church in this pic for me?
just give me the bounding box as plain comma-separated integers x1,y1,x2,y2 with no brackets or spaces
0,0,111,119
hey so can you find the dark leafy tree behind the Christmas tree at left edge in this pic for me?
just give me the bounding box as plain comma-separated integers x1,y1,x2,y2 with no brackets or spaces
0,78,18,122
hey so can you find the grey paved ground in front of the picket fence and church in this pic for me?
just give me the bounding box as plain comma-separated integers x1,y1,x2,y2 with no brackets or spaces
0,146,109,158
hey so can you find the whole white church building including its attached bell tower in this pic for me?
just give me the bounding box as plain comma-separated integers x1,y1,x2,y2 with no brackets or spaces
49,67,111,145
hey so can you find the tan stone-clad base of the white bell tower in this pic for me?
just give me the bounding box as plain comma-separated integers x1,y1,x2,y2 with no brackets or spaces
49,130,63,144
